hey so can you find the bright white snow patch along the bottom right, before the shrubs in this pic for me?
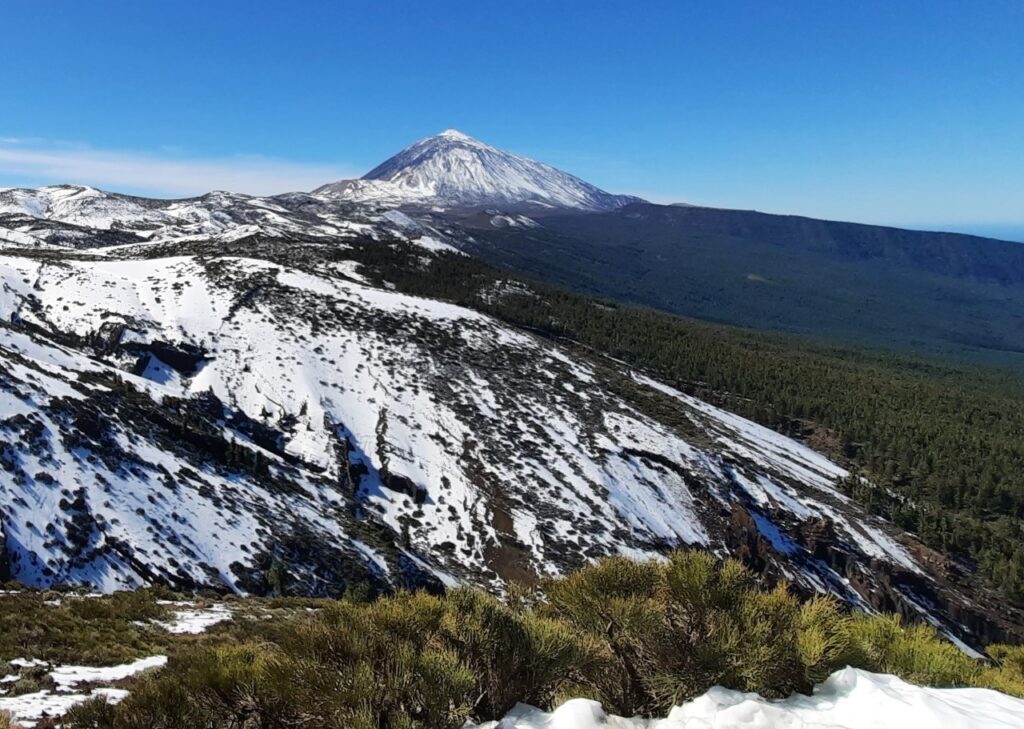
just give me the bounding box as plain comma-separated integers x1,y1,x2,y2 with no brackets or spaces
466,668,1024,729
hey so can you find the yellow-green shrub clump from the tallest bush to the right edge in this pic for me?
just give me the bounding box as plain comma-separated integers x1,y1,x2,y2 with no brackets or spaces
539,552,1024,716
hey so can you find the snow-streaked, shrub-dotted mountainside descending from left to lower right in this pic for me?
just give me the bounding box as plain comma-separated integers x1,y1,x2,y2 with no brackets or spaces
0,186,1024,643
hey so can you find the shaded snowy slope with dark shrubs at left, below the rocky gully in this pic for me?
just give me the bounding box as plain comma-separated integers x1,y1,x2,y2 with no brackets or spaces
0,321,395,591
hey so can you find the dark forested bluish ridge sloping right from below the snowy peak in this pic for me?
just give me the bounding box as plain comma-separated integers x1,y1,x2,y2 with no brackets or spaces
452,204,1024,368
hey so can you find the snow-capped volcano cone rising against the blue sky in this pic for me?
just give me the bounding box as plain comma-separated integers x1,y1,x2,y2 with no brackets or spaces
314,129,640,210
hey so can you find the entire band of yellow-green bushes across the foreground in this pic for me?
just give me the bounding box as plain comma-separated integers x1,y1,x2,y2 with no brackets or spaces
54,552,1024,729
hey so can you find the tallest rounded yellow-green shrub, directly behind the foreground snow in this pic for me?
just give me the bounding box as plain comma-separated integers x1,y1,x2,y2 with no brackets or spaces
545,552,808,715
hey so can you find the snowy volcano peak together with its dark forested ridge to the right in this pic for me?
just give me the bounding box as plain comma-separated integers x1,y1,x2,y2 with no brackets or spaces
314,130,1024,368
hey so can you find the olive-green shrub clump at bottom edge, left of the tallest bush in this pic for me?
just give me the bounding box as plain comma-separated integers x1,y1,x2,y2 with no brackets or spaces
79,594,474,729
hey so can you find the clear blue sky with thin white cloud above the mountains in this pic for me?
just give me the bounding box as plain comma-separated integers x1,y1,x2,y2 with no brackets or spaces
0,0,1024,232
